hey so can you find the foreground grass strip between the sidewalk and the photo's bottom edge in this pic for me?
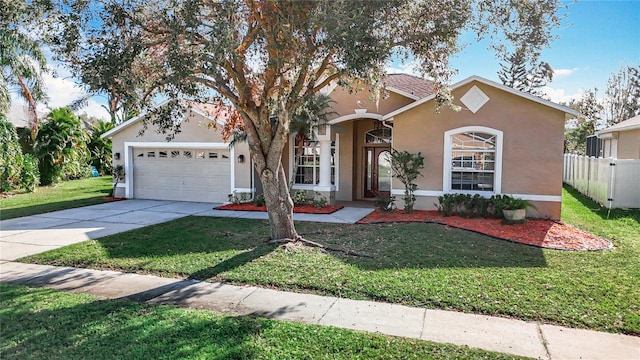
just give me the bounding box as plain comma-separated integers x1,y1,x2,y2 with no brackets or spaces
0,284,514,360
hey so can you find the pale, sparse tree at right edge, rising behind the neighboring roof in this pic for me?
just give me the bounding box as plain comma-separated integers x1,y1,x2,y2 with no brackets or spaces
605,66,640,126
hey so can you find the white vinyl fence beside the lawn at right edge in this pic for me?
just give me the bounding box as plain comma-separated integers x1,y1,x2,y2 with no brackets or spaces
562,154,640,208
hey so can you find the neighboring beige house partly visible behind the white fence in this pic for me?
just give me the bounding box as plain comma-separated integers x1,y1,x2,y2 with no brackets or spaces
596,115,640,159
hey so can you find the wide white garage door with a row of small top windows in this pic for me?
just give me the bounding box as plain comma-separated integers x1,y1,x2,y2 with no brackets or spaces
133,148,231,202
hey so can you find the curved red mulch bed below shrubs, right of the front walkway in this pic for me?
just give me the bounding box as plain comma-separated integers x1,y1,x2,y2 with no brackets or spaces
358,209,613,250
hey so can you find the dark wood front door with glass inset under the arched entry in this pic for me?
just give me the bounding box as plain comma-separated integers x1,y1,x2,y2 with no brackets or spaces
364,147,391,198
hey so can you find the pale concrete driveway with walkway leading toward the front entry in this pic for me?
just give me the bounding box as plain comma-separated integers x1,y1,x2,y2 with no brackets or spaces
0,200,373,262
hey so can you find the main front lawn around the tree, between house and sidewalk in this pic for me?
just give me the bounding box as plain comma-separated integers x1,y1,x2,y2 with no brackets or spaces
23,186,640,334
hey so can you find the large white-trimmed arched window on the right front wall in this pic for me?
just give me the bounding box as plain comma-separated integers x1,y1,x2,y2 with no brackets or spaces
443,126,502,193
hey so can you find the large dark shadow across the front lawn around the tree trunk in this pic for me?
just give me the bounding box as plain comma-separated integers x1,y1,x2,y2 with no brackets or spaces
86,217,547,280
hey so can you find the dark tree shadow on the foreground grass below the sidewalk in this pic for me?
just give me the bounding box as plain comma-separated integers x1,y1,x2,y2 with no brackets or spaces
0,287,270,359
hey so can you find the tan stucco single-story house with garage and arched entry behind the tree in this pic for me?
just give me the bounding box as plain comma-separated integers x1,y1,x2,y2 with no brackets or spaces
104,74,577,219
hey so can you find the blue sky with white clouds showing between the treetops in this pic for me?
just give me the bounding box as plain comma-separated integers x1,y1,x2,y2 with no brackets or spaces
25,0,640,119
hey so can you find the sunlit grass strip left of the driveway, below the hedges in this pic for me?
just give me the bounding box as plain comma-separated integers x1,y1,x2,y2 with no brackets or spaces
0,176,112,220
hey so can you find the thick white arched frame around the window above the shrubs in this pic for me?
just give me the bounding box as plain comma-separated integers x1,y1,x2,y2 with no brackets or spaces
442,126,503,195
